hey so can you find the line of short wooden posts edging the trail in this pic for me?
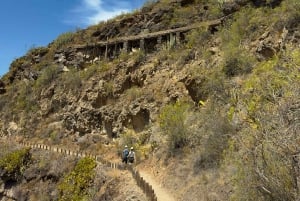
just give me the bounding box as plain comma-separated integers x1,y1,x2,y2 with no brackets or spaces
20,142,157,201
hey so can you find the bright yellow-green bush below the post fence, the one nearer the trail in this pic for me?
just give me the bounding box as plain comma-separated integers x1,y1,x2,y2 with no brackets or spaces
58,158,96,201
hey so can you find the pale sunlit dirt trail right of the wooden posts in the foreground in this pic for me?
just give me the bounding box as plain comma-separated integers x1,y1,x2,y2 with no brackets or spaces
139,170,176,201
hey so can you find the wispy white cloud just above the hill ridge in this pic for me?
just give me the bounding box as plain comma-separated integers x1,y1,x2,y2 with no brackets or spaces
67,0,130,26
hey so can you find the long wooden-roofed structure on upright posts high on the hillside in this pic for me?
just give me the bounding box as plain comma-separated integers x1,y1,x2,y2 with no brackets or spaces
58,15,230,65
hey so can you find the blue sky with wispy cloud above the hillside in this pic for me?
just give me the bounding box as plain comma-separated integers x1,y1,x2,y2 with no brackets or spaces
0,0,146,76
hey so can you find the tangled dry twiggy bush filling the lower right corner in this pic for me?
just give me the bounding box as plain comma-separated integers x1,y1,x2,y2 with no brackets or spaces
228,106,299,201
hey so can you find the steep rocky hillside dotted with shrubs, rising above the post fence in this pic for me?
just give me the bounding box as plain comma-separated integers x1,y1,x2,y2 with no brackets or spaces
0,0,300,201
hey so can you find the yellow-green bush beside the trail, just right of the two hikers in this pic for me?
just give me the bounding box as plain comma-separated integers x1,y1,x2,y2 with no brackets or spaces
159,101,189,152
